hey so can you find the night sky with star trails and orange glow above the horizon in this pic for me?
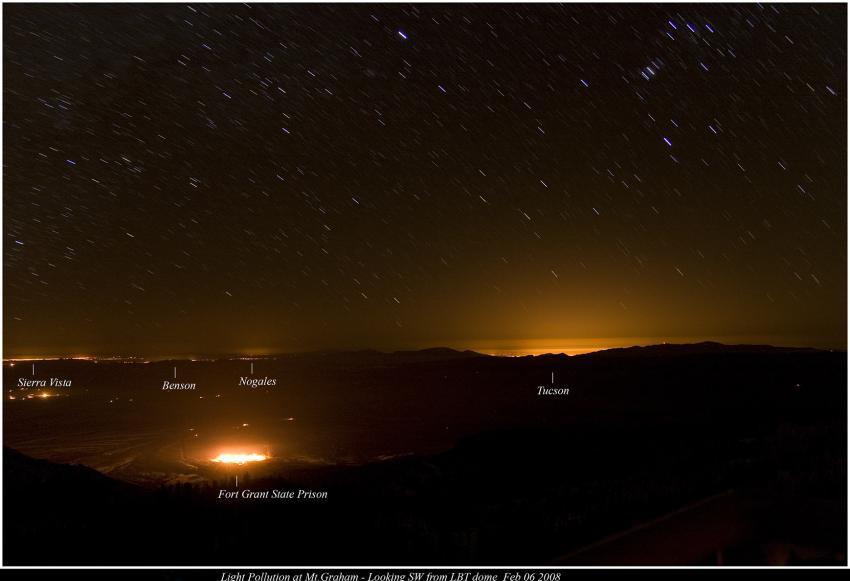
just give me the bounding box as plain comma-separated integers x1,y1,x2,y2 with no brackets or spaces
3,4,847,357
